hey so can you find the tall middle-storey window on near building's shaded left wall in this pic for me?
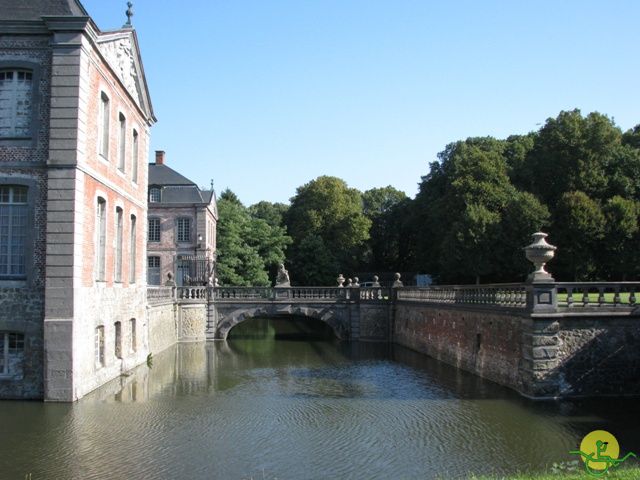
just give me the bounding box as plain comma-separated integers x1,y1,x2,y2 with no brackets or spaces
0,185,28,278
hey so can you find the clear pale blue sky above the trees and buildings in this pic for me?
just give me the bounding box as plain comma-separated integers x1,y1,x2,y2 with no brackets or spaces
81,0,640,205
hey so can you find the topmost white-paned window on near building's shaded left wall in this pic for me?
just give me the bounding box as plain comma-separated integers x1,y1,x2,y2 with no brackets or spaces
0,70,33,138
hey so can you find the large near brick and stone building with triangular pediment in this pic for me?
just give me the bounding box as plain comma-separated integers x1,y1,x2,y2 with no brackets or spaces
0,0,155,401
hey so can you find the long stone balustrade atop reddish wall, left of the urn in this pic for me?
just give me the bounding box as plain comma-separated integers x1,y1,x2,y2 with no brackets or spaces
396,283,527,308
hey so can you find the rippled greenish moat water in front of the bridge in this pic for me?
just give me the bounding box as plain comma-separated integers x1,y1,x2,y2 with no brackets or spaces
0,320,640,480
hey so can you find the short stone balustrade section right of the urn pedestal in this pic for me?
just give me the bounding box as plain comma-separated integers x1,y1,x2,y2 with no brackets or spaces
555,282,640,309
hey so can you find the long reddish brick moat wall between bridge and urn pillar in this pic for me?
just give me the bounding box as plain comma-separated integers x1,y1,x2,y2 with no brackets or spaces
393,302,526,391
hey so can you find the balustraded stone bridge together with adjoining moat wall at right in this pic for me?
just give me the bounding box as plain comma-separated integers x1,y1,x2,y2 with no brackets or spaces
148,281,640,398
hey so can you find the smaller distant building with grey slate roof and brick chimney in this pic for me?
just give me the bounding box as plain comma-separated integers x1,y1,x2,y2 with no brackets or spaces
147,151,218,286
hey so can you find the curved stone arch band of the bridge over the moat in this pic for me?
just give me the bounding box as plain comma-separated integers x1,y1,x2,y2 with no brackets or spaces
216,305,349,340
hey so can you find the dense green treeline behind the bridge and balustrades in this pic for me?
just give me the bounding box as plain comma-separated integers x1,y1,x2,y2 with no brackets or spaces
218,110,640,285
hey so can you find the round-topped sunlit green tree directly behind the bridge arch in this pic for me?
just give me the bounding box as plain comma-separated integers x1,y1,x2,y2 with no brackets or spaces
285,176,371,285
